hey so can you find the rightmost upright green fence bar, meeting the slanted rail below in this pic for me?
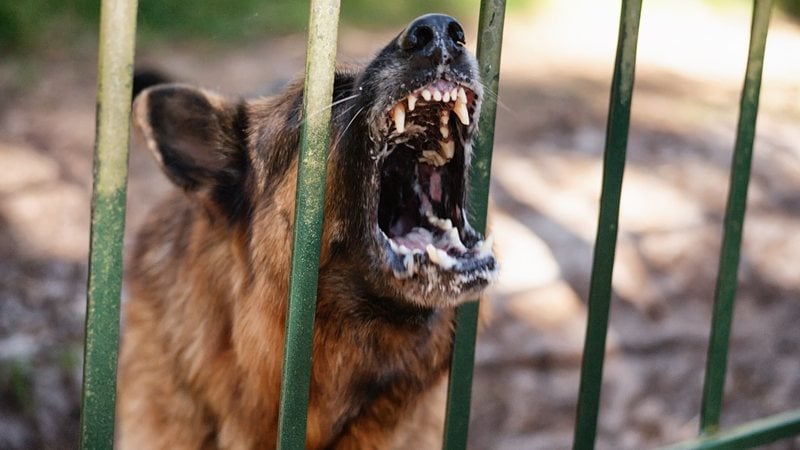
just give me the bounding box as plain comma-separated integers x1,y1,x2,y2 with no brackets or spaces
700,0,772,434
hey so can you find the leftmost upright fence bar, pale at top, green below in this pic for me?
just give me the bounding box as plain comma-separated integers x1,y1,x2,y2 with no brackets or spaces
80,0,137,449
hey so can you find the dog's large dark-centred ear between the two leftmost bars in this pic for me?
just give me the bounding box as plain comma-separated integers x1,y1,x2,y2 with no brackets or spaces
133,84,246,191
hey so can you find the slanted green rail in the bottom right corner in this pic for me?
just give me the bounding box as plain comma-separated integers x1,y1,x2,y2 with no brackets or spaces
663,410,800,450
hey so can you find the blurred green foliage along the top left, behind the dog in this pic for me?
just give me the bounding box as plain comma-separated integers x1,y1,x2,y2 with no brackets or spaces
0,0,539,52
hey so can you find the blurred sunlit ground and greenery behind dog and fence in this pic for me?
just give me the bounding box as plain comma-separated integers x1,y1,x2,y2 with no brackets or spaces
0,0,800,449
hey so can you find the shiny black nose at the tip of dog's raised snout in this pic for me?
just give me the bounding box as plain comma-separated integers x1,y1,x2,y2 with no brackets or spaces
397,14,464,64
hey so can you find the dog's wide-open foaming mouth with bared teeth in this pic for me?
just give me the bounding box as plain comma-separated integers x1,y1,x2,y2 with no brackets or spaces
376,79,495,287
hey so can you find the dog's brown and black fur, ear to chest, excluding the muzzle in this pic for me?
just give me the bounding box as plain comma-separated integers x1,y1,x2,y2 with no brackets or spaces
117,14,494,449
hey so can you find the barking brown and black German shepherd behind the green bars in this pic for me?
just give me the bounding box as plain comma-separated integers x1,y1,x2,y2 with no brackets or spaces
117,14,496,450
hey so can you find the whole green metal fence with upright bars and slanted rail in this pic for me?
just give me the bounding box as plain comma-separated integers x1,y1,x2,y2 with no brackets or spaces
81,0,800,449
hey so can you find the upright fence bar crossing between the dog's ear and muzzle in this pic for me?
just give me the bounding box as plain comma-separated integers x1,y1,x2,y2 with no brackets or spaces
278,0,339,449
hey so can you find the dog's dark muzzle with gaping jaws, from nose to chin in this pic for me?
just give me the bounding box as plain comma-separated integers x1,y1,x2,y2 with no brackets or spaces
331,14,496,307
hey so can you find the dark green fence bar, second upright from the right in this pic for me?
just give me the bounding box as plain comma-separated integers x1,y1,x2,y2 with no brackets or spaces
573,0,642,449
